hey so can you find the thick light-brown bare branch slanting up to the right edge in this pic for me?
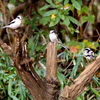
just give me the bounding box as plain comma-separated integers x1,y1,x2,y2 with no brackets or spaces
60,56,100,100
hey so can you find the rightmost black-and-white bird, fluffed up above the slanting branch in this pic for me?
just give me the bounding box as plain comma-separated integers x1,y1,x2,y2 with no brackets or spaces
83,48,95,60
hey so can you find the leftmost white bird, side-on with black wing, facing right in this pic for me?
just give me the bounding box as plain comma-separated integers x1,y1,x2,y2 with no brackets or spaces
0,16,22,29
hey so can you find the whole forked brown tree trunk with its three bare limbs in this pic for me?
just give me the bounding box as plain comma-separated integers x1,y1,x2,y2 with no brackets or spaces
0,30,100,100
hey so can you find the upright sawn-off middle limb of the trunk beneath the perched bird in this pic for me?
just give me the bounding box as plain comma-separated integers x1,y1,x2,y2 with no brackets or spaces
46,42,57,80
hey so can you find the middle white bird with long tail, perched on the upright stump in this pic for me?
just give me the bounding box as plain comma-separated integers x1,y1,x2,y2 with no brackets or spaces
49,30,70,50
